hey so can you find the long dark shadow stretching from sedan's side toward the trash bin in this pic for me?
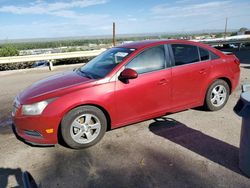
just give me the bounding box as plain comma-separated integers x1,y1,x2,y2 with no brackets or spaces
149,117,244,175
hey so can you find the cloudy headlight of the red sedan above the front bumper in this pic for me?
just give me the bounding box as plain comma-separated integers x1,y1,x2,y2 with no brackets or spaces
22,99,54,115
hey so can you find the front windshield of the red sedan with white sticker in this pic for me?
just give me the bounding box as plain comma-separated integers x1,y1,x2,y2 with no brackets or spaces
78,48,135,79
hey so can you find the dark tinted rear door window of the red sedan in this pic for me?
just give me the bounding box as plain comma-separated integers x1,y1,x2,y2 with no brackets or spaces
171,44,200,66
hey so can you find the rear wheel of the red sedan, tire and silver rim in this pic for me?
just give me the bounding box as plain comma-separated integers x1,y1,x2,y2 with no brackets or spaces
205,79,230,111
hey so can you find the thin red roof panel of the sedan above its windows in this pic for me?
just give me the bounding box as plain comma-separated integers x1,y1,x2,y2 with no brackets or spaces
117,39,207,49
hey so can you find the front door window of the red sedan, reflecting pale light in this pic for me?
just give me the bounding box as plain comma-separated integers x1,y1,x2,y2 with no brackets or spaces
126,46,165,74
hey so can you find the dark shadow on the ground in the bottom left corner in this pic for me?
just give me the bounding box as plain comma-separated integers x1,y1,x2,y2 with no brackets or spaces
0,168,23,188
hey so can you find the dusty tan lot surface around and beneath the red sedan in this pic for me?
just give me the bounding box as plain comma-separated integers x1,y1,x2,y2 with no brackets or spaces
0,61,250,188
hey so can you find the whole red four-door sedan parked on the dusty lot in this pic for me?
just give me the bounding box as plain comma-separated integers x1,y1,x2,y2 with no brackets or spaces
12,40,240,148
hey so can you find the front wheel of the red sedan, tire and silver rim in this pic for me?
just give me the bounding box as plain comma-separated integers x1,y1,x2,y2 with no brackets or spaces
61,106,107,149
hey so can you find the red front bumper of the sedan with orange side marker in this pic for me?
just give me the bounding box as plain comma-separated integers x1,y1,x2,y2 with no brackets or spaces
12,96,61,146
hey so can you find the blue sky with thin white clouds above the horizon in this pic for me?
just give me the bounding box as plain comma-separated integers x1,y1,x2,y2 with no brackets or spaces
0,0,250,40
